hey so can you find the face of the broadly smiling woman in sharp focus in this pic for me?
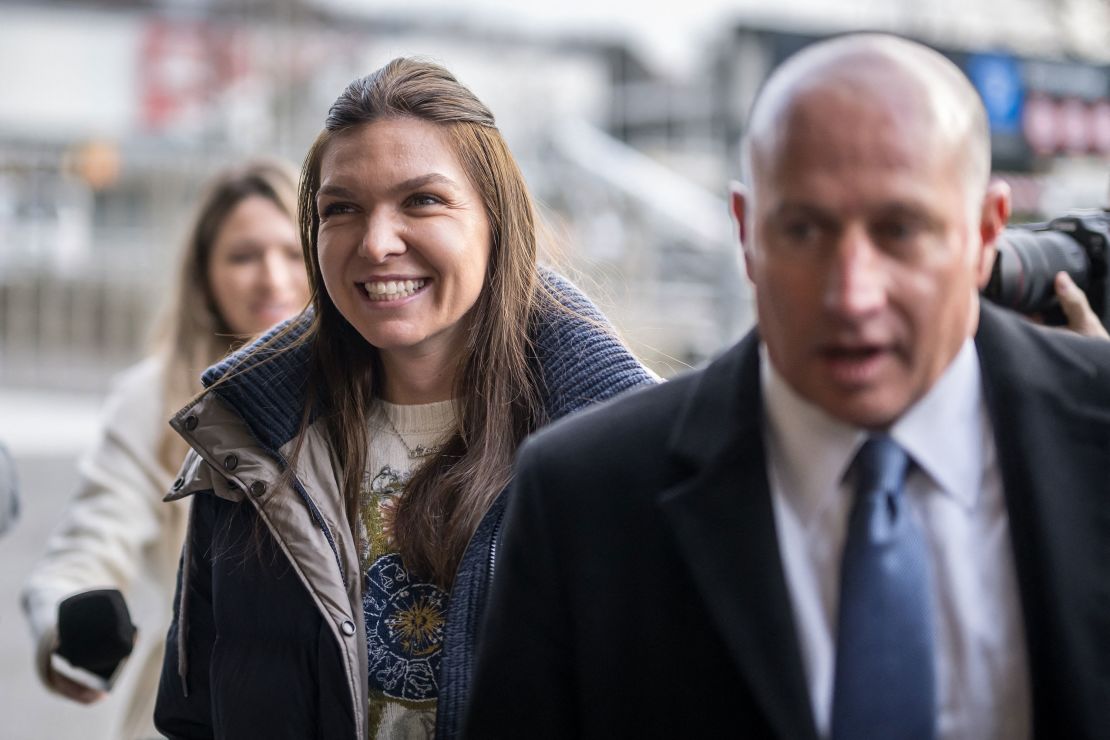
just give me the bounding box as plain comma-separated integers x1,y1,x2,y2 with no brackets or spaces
316,118,491,366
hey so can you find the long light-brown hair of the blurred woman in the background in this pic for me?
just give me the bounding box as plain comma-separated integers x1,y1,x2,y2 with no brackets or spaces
153,160,296,473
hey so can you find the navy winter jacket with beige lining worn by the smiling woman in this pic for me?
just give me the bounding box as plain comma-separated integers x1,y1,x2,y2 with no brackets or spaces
154,272,656,740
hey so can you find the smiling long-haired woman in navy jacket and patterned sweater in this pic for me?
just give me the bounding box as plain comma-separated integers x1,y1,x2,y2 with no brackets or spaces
157,54,653,738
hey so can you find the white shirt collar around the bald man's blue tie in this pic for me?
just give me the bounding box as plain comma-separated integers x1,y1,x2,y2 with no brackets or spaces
759,338,989,527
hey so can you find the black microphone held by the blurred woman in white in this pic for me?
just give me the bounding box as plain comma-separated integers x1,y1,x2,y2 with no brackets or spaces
54,588,137,682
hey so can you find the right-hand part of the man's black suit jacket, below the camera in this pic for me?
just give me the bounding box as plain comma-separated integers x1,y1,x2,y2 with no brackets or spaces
976,304,1110,737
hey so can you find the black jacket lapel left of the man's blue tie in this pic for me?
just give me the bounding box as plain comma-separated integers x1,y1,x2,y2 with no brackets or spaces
659,332,816,738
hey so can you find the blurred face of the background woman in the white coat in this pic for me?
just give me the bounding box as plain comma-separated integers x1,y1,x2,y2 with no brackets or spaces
208,195,309,335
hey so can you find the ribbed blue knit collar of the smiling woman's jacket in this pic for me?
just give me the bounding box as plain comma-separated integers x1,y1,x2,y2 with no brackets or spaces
202,270,654,452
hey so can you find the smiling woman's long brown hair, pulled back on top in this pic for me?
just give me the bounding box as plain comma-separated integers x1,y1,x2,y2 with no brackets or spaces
294,58,554,587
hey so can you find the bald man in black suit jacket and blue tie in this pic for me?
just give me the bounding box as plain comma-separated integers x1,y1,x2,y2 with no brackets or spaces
468,36,1110,740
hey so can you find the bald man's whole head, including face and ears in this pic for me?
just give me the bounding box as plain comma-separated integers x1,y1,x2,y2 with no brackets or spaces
730,36,1009,429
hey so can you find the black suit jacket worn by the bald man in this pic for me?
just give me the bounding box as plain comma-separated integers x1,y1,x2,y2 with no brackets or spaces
468,305,1110,740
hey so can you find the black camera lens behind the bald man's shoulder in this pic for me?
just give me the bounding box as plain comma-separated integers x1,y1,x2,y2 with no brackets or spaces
983,229,1091,314
